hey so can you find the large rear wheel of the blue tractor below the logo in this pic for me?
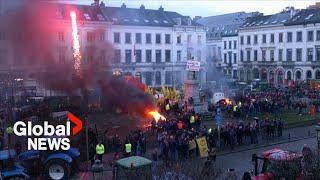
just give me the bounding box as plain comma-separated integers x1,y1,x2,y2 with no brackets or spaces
45,159,70,180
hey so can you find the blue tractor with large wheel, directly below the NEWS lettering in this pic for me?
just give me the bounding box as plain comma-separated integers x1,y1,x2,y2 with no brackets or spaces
19,148,80,180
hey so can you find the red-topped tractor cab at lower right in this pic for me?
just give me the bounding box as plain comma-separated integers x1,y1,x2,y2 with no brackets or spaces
252,148,302,180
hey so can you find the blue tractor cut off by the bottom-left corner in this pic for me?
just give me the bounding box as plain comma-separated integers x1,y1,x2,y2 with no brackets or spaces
0,149,29,179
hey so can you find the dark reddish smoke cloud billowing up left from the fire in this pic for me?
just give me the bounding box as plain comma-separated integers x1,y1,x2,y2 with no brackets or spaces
0,0,155,114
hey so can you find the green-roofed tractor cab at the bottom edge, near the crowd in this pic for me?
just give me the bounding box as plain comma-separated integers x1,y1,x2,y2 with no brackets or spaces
115,156,152,180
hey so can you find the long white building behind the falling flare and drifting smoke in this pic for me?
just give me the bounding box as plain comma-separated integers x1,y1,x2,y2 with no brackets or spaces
0,0,206,96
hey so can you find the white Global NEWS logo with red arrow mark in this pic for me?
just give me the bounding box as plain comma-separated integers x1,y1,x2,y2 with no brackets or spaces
13,112,82,151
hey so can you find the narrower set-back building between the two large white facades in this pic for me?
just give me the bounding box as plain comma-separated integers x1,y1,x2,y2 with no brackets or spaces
197,12,259,79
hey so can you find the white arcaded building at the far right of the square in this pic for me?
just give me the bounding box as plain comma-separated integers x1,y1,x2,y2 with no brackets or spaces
238,8,320,85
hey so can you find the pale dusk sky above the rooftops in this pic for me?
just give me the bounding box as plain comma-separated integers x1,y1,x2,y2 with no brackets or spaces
61,0,319,17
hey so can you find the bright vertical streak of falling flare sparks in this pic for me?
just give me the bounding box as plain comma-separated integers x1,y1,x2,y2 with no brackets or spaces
70,11,81,75
